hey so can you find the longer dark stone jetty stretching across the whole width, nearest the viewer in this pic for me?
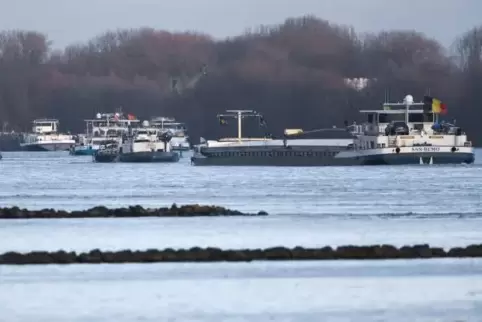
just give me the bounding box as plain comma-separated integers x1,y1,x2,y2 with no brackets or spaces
0,244,482,265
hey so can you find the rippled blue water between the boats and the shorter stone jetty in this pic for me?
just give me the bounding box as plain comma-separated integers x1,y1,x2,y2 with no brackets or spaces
0,151,482,216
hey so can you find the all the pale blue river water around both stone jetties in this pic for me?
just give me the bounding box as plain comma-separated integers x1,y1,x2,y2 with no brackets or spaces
0,151,482,321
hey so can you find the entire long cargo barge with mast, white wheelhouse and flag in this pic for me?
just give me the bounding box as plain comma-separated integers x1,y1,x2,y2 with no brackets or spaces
191,95,474,166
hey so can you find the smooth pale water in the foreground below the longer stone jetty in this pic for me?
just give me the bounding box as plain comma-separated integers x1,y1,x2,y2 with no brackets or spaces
0,260,482,322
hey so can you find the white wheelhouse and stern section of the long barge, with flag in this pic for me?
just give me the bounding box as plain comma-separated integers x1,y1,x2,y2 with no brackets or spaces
334,95,475,165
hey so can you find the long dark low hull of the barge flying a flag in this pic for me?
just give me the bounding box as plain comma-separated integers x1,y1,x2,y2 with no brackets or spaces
191,147,475,167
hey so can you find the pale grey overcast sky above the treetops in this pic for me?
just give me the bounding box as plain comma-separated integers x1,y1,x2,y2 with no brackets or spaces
0,0,482,48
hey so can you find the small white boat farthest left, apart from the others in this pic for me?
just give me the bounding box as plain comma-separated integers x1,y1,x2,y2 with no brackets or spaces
20,119,75,151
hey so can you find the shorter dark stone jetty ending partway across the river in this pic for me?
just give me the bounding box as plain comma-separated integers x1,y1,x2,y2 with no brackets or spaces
0,204,268,219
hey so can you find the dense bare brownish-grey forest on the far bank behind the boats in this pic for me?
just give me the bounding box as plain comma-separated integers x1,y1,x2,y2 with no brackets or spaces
0,16,482,144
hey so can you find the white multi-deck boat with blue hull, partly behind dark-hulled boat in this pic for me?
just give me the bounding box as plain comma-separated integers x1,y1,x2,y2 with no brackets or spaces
71,112,139,155
